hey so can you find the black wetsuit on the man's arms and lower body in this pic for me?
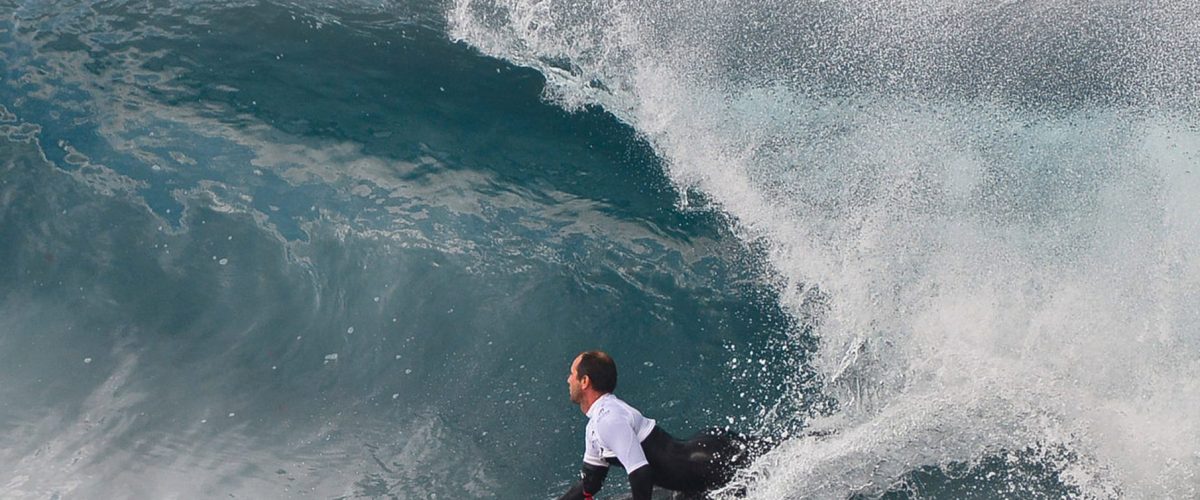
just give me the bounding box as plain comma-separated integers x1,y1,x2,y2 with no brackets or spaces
559,426,760,500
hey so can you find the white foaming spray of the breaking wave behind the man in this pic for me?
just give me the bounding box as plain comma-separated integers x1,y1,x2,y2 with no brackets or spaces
449,0,1200,499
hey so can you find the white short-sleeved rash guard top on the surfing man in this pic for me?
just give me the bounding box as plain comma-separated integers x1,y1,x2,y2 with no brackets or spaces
583,393,654,472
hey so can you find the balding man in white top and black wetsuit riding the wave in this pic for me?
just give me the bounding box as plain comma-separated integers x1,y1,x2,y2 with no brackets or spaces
559,351,758,500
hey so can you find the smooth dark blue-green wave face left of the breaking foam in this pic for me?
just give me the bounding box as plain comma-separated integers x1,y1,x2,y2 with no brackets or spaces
0,2,816,499
